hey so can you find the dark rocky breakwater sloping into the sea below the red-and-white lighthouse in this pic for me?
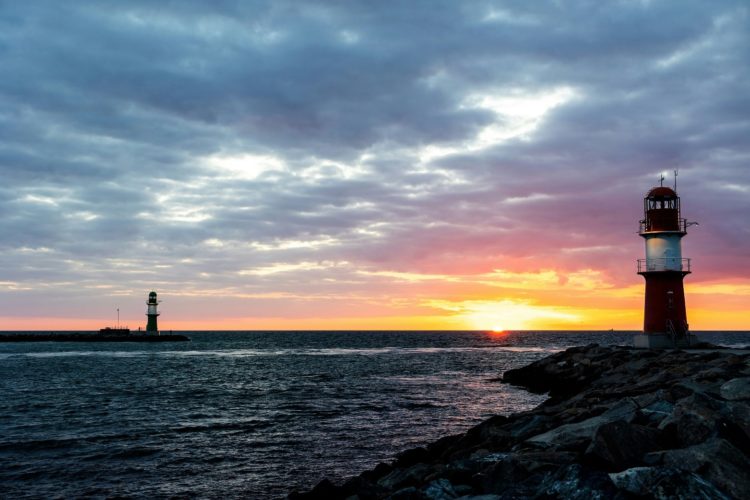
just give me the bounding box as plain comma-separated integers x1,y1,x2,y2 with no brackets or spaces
290,345,750,500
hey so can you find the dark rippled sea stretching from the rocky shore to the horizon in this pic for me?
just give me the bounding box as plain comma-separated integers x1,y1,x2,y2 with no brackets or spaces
0,331,750,499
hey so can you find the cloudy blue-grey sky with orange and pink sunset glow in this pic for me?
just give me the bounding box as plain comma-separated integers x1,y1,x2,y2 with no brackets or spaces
0,0,750,330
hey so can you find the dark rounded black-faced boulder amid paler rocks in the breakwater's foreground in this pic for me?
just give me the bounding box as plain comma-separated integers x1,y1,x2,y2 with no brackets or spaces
585,420,659,471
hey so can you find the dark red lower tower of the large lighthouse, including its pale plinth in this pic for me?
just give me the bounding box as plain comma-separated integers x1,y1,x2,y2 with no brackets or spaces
634,271,697,349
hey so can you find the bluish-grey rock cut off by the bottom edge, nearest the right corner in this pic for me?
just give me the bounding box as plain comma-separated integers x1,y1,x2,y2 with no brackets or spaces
609,467,728,500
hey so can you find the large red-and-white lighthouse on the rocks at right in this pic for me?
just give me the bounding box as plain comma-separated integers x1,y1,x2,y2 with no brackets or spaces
634,177,696,349
